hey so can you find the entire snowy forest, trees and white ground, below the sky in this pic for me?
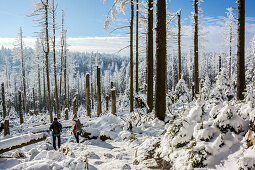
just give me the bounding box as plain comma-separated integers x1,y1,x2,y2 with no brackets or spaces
0,0,255,170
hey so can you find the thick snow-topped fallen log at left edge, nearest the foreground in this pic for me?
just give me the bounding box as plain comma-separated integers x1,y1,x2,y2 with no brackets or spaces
0,134,47,154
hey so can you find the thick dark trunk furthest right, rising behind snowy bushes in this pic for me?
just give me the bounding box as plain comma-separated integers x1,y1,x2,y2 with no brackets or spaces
236,0,246,100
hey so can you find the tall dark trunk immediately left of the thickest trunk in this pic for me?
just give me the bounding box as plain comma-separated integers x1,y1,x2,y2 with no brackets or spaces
146,0,153,112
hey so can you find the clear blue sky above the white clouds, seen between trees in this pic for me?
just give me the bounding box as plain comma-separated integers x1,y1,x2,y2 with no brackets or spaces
0,0,255,53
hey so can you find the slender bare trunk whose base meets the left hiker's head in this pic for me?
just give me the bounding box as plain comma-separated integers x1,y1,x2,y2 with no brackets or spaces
52,0,61,119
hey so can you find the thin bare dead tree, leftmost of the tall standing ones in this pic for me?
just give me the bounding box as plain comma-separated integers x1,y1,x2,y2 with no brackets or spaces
20,28,28,115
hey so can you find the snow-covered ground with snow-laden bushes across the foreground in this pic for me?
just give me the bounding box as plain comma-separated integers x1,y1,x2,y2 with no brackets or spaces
0,81,255,170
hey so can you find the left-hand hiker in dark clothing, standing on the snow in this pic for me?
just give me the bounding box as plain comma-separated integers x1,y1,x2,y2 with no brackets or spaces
50,118,62,150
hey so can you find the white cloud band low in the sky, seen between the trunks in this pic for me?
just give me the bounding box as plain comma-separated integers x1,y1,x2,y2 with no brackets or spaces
0,16,255,56
